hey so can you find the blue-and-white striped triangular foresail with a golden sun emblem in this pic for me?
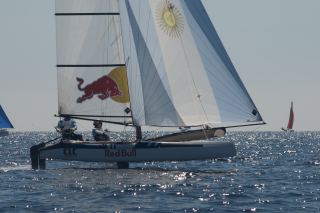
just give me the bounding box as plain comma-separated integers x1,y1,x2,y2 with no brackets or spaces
119,0,262,126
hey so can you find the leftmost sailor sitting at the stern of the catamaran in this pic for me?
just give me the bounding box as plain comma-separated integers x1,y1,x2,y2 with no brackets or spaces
56,116,83,141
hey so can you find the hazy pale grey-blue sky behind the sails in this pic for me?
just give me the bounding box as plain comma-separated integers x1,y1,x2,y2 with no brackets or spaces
0,0,320,131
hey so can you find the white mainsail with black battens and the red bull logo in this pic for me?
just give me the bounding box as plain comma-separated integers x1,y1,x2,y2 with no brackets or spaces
56,0,131,122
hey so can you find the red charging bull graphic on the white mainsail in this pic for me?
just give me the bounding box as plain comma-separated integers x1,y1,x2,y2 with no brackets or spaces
77,75,123,103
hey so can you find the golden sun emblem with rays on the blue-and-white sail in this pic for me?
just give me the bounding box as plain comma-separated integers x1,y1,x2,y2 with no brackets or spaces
156,0,184,38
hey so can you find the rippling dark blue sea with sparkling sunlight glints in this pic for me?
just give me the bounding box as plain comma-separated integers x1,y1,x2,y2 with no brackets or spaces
0,132,320,213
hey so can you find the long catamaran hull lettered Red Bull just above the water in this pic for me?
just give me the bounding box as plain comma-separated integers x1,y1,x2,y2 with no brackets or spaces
39,141,236,162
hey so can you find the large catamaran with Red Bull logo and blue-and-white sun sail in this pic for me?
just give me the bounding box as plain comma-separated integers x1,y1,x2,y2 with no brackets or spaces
31,0,264,169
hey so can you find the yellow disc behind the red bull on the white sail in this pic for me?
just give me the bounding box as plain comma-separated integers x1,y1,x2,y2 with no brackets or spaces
108,67,130,103
